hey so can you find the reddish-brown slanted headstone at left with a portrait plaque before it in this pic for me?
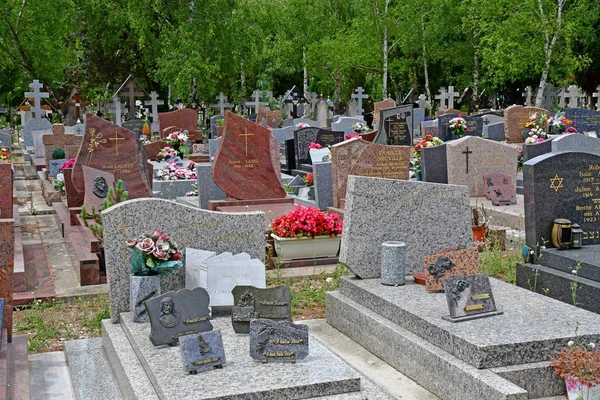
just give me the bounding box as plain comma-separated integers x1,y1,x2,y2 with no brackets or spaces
71,113,152,199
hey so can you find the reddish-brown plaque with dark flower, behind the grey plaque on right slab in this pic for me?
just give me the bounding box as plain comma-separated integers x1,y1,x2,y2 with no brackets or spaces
423,247,479,292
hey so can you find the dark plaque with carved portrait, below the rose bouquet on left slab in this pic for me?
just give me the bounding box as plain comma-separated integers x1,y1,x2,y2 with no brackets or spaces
144,288,212,346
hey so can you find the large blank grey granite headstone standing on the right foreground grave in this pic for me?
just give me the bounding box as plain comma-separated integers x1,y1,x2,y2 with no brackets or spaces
340,176,473,278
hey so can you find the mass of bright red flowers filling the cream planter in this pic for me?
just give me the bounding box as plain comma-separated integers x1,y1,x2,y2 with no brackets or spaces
271,205,343,238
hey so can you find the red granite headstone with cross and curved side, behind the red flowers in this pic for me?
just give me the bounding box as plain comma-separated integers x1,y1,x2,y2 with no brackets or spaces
212,111,285,200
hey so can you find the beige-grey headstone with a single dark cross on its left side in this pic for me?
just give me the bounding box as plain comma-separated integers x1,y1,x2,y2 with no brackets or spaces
446,136,519,197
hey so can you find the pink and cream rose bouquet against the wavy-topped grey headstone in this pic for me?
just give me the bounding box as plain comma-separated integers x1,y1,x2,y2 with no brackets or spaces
126,229,183,276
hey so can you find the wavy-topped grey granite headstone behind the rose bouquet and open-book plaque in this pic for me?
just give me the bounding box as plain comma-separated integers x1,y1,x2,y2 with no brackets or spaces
102,199,265,323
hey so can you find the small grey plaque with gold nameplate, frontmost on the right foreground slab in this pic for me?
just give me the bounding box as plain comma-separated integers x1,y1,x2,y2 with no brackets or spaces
442,274,503,322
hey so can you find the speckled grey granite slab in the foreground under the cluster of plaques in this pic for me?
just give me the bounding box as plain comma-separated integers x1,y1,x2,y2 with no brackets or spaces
121,313,361,400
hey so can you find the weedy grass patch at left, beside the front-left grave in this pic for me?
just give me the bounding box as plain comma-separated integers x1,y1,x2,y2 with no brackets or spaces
13,295,110,353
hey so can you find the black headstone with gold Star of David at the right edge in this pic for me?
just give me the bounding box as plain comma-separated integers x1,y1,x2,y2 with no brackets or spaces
523,151,600,249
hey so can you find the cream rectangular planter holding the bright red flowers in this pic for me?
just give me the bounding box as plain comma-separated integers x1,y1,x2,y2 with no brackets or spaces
271,233,342,261
